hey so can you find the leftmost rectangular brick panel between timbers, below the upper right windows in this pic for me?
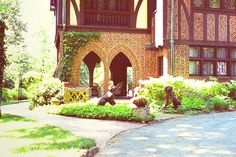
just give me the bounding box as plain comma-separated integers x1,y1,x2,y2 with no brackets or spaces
194,13,203,40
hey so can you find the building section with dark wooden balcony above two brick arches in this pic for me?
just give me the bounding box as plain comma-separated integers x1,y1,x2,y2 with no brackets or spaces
51,0,157,95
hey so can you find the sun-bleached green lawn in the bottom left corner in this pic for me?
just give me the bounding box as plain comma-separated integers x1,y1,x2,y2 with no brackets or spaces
0,114,95,157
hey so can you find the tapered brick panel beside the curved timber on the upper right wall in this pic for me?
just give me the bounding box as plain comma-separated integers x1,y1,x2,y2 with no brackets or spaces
181,7,189,40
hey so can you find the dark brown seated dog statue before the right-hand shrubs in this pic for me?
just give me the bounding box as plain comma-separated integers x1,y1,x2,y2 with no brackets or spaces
164,86,181,110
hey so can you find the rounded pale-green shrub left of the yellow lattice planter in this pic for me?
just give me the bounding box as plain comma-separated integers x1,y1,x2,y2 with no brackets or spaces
31,78,63,106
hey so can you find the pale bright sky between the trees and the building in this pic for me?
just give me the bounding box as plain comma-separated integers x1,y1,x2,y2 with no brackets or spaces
21,0,55,57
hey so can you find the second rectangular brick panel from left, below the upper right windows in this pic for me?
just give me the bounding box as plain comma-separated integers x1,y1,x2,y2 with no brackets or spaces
207,14,215,41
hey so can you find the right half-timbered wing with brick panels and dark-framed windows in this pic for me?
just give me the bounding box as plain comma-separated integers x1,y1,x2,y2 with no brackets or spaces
156,0,236,80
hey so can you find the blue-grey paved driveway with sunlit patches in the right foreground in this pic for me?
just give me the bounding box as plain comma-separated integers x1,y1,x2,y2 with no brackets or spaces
97,112,236,157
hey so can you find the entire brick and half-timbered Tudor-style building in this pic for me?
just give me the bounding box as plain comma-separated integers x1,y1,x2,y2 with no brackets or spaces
51,0,236,95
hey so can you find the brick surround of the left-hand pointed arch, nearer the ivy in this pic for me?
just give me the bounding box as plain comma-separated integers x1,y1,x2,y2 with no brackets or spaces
70,42,109,89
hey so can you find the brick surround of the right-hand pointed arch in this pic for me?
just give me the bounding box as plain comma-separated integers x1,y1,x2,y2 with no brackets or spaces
108,44,141,86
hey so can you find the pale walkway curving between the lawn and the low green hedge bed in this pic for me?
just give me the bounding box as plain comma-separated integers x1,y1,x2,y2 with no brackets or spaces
1,102,145,147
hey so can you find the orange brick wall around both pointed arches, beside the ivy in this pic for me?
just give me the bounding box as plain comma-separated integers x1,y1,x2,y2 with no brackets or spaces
57,32,153,90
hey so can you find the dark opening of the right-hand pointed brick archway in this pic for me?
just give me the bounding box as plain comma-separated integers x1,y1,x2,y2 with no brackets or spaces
110,52,133,96
